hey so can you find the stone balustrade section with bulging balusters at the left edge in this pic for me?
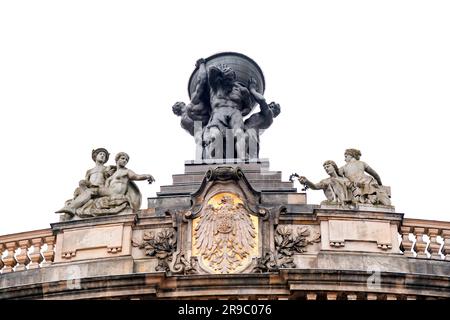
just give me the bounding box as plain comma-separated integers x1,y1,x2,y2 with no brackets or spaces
0,229,55,273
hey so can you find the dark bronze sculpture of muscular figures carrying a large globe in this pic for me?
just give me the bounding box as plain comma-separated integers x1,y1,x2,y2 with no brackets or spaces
172,52,280,159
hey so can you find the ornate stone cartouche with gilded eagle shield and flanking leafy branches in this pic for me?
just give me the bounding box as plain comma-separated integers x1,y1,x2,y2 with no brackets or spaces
133,166,320,275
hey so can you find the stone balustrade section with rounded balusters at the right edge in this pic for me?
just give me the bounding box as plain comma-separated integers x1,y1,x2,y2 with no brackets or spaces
399,219,450,260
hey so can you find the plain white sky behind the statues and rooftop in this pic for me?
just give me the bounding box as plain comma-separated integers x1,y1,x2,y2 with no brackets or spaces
0,0,450,234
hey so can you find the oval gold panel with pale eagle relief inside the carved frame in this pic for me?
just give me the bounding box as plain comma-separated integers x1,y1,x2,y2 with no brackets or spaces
193,193,257,273
